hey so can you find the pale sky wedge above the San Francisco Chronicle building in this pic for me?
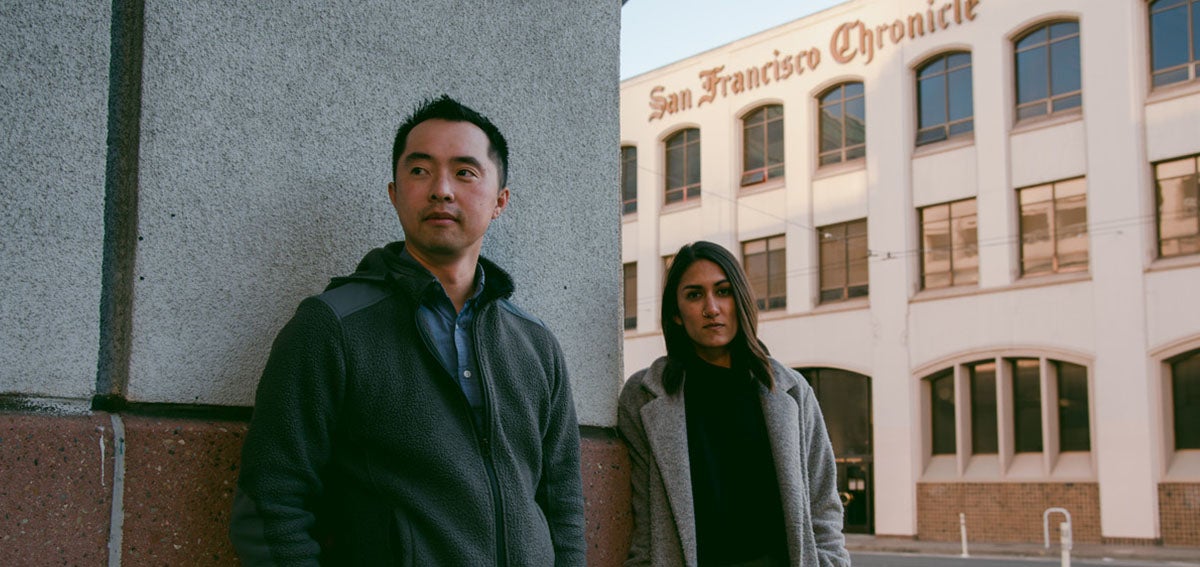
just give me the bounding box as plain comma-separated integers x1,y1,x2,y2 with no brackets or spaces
620,0,847,80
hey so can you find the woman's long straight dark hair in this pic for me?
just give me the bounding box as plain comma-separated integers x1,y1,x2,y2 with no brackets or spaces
661,240,775,394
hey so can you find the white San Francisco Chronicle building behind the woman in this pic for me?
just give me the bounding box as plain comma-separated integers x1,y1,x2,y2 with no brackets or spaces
620,0,1200,547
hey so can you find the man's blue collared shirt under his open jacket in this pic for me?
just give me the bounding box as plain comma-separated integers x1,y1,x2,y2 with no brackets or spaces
401,250,484,426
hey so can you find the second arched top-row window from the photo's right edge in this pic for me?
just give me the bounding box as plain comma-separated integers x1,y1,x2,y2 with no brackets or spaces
1014,22,1082,120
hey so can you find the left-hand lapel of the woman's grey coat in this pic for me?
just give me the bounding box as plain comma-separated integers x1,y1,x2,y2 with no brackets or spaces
642,367,696,565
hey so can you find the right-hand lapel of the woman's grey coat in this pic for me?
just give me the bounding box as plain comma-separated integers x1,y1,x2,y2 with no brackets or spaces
758,365,808,565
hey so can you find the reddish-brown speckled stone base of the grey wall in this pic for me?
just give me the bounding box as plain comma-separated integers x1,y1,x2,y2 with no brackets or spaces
0,412,630,566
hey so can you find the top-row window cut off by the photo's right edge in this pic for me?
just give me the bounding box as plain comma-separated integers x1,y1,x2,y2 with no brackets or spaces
1150,0,1200,86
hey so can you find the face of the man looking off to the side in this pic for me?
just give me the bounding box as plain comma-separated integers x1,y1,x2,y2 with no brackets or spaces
388,120,509,262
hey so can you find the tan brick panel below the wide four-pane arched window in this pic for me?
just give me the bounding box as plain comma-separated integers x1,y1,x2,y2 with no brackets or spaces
917,483,1100,543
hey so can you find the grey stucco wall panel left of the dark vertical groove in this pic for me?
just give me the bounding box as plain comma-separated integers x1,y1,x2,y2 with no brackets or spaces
0,0,110,399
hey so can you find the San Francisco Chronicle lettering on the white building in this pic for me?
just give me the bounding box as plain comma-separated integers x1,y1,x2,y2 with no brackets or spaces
649,0,983,121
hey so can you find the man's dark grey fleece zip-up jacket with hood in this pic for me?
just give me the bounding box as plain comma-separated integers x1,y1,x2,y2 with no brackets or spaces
230,243,584,566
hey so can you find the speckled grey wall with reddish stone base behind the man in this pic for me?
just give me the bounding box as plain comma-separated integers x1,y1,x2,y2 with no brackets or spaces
0,0,628,563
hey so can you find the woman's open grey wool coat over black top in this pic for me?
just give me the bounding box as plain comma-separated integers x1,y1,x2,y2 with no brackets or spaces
617,358,850,567
